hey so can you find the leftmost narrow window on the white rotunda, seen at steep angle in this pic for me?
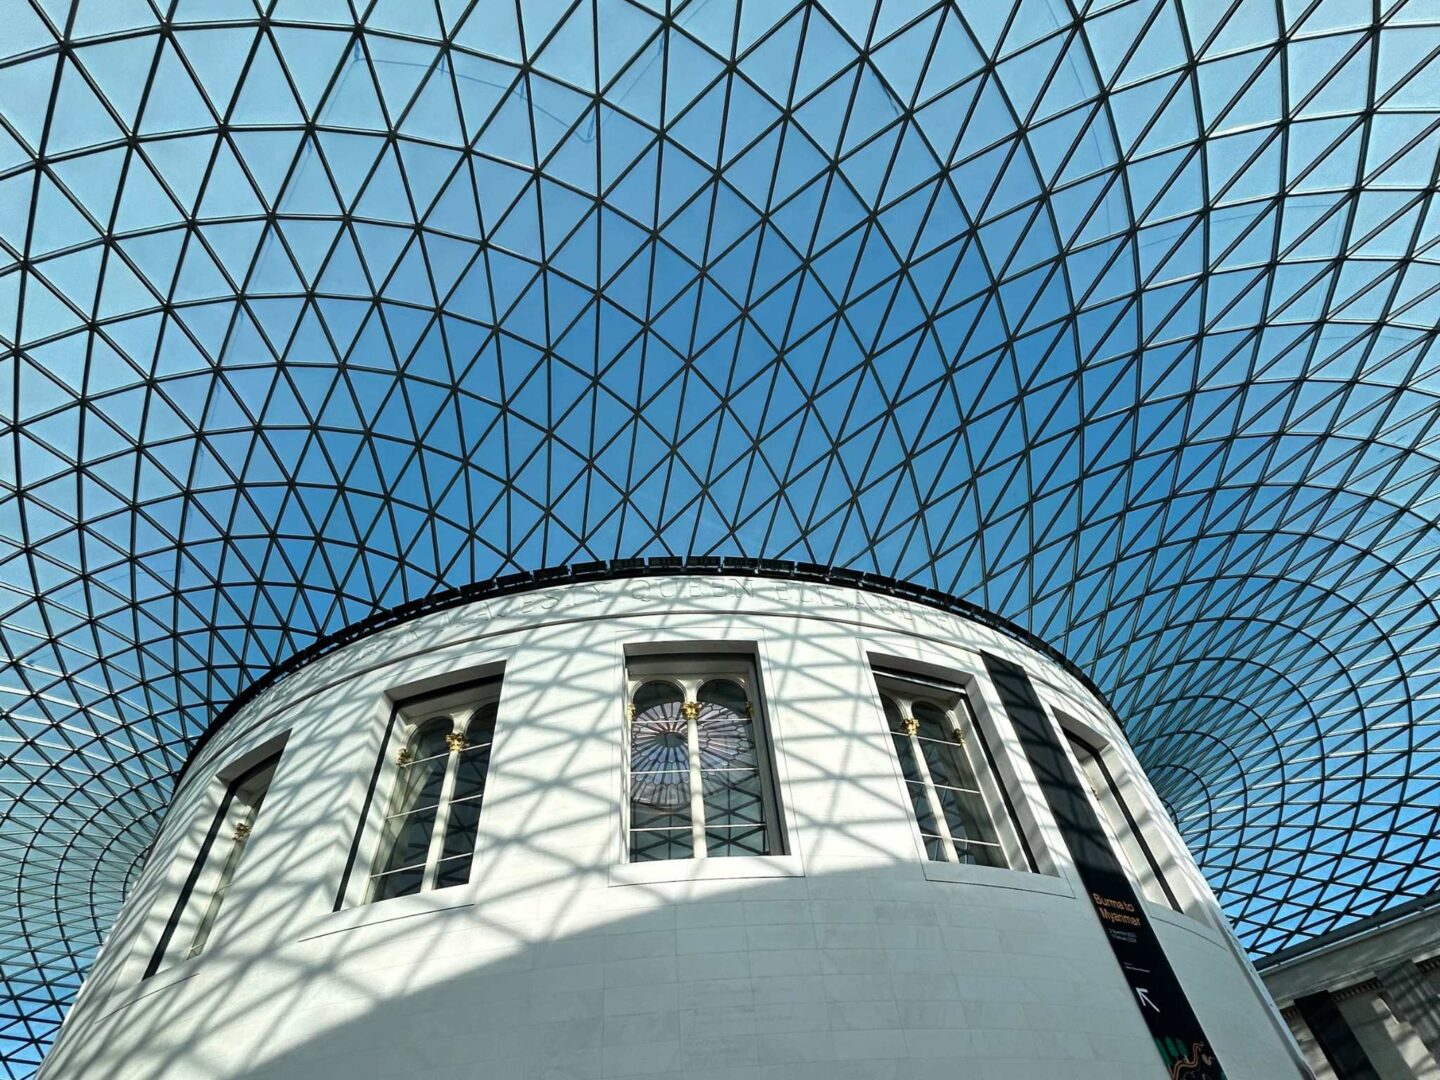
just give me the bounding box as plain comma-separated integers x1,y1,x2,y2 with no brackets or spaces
145,753,279,978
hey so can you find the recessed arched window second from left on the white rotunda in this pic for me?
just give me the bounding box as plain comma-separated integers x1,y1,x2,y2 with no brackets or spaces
366,680,500,903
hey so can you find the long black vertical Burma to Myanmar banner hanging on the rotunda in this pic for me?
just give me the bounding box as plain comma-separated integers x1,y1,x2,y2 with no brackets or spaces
982,652,1225,1080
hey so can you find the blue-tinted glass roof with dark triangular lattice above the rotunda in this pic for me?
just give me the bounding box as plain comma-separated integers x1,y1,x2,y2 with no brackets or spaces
0,0,1440,1076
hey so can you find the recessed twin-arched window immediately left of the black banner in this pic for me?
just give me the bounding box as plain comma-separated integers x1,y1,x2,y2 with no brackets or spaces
876,672,1012,867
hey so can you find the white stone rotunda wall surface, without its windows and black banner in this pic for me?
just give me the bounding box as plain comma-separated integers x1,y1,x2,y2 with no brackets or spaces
42,577,1296,1080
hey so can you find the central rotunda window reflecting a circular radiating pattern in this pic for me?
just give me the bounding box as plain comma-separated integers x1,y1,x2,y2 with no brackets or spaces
626,655,785,863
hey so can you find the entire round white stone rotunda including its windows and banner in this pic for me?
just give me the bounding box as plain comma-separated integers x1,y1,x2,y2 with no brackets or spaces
42,570,1303,1080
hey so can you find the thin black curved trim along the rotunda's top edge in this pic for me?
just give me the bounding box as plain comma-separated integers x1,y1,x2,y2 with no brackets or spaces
176,556,1125,786
